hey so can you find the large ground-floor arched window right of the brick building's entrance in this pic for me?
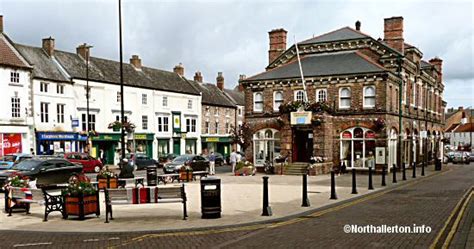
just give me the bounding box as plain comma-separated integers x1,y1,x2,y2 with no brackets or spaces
340,127,375,168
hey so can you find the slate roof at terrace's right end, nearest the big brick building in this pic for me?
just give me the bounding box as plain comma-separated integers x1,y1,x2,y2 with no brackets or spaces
190,81,236,108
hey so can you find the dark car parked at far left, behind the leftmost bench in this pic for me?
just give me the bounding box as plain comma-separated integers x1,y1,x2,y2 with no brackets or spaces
0,158,82,188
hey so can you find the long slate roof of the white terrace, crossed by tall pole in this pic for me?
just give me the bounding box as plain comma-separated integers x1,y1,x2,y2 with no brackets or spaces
55,51,199,95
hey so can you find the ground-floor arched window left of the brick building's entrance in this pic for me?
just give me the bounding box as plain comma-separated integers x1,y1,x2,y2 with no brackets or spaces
253,129,280,166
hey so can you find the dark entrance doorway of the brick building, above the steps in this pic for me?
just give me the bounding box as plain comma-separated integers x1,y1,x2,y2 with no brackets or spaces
293,130,313,162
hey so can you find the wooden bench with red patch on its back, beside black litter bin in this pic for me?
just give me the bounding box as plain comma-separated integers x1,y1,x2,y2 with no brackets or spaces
104,184,188,223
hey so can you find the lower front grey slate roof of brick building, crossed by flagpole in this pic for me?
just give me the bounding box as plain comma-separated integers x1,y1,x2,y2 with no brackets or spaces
247,51,386,80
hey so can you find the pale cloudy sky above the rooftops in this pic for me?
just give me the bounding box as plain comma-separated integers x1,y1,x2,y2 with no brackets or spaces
0,0,474,107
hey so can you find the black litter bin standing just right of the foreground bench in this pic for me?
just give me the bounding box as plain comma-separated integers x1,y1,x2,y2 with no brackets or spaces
201,176,222,219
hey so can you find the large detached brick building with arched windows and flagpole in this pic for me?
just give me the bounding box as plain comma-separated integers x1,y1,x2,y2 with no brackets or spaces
240,17,446,172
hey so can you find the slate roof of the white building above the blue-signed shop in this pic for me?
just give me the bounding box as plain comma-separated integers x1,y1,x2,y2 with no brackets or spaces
15,44,70,82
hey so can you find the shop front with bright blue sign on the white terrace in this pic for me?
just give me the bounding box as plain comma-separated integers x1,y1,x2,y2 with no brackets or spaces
36,132,87,155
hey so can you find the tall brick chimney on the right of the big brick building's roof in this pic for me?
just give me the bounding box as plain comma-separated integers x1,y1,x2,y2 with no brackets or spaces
383,16,405,54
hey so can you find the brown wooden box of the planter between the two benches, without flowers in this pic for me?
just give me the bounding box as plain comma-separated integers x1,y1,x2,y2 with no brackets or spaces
64,192,100,220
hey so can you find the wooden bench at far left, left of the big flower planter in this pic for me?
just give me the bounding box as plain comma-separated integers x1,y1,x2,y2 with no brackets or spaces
5,187,67,221
